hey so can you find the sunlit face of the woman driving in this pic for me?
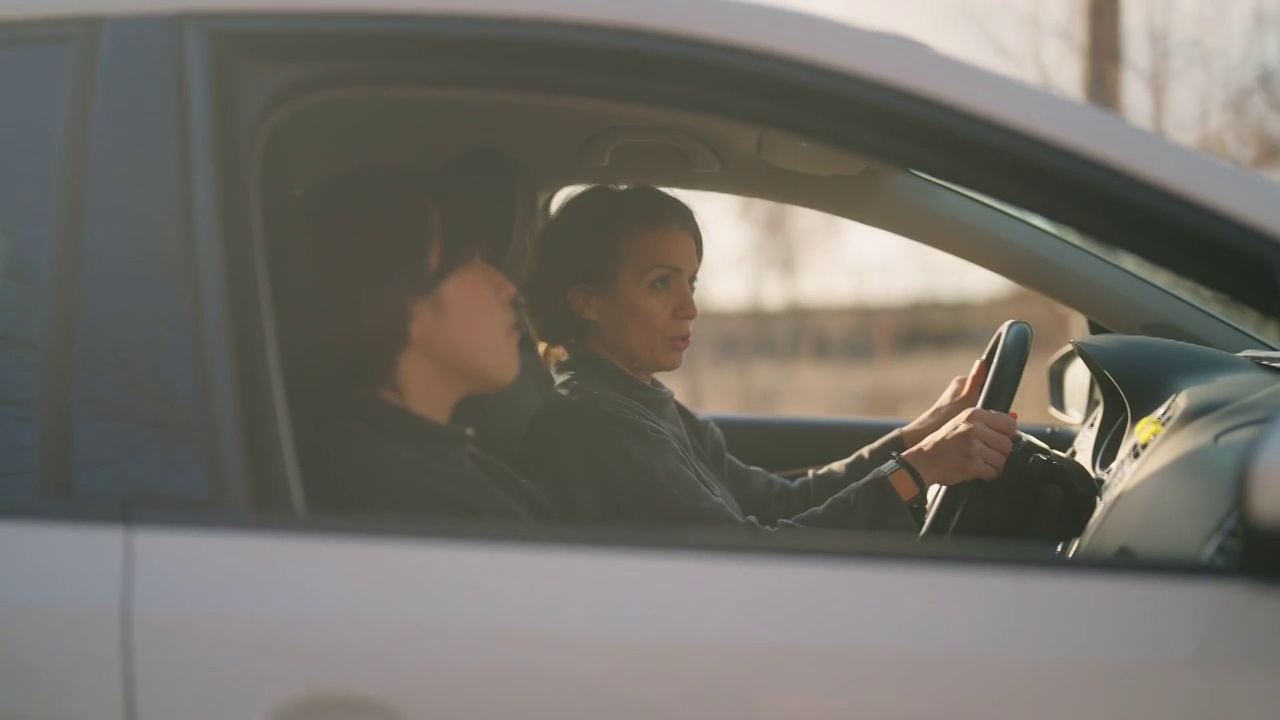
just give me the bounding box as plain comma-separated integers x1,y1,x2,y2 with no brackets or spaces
572,228,699,382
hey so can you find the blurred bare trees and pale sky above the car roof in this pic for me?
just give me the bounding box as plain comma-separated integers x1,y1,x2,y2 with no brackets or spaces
969,0,1280,179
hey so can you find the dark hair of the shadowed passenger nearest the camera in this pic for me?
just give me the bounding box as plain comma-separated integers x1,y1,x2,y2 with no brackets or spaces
305,168,484,389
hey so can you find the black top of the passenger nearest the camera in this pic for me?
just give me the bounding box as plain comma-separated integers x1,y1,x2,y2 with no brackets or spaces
328,395,556,521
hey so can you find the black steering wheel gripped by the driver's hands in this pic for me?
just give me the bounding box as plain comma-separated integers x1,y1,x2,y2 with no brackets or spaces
920,320,1032,538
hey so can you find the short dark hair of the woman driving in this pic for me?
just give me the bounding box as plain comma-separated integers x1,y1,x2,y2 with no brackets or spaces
522,184,703,361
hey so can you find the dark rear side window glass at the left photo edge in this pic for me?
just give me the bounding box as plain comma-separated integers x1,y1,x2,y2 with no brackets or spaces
0,41,68,498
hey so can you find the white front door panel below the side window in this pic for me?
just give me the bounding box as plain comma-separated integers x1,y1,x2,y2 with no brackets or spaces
134,527,1280,720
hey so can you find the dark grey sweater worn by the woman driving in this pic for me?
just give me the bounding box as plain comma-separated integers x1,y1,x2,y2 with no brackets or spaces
522,352,916,532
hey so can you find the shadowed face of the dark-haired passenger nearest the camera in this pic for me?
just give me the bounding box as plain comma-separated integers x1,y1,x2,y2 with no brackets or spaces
410,253,520,397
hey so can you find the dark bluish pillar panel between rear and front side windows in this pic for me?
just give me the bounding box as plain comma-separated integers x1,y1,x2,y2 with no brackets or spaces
72,20,209,500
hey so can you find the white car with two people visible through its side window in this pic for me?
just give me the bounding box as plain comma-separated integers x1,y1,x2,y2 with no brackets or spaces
0,0,1280,720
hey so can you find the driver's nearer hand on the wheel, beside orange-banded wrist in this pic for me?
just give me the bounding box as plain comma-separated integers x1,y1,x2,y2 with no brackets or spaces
902,407,1018,486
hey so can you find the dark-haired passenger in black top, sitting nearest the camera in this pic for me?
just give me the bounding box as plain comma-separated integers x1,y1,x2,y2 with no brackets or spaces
306,168,552,521
